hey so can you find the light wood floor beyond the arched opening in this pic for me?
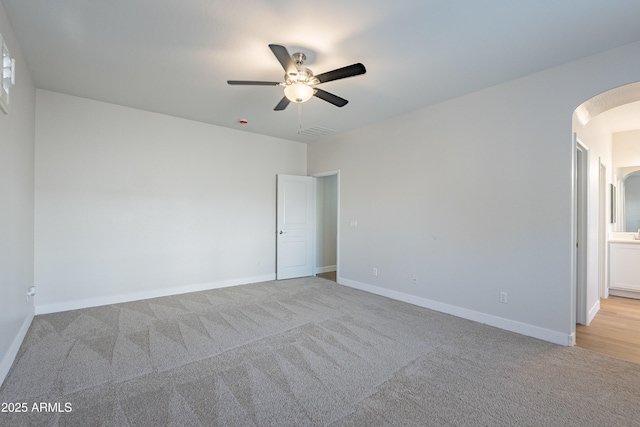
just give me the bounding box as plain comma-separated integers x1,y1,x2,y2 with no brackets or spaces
576,296,640,364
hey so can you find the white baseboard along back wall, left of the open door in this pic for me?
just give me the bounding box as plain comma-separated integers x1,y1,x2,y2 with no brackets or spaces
35,274,276,314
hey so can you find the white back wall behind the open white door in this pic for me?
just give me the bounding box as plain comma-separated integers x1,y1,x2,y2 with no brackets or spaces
35,90,307,313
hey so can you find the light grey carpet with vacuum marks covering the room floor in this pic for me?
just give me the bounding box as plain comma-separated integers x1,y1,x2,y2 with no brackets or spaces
0,278,640,427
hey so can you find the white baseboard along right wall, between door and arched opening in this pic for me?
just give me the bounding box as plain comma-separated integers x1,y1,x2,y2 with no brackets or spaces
338,277,575,346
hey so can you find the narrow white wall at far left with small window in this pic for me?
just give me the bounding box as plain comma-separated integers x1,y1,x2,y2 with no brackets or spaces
0,2,35,382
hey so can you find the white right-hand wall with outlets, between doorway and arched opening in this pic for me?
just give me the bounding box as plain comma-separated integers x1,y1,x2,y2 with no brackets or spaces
308,39,640,344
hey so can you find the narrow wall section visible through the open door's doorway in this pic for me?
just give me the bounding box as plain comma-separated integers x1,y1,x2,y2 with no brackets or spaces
316,174,338,273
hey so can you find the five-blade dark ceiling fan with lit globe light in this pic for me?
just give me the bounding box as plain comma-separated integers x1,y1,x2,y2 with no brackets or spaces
227,44,367,111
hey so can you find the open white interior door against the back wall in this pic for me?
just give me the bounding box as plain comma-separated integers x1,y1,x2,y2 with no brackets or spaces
276,175,316,280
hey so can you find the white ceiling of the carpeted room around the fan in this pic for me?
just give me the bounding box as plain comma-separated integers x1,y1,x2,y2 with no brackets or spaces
0,0,640,142
